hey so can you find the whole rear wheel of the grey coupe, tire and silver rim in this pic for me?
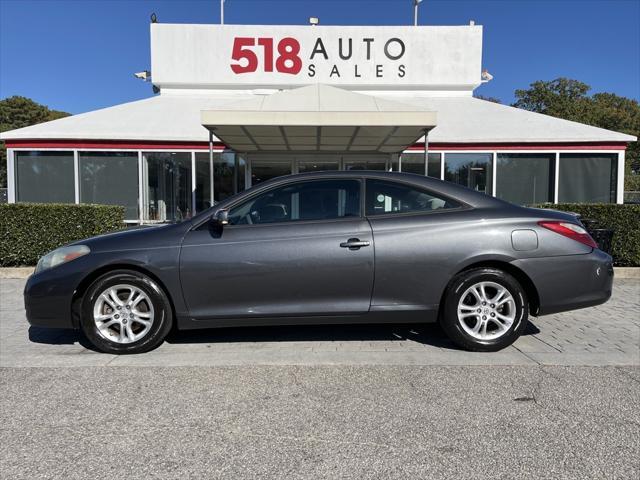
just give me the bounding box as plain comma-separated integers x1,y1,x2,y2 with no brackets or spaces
440,268,529,352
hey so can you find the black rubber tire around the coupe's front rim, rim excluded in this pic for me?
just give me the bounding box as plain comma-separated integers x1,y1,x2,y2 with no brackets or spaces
80,270,173,355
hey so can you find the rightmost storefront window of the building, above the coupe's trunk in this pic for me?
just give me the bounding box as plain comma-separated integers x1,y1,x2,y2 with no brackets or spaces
558,153,618,203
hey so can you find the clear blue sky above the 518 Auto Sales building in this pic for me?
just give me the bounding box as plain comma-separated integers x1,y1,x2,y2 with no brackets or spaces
0,0,640,113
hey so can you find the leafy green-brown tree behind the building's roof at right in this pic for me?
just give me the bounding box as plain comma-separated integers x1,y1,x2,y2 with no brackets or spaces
512,78,640,191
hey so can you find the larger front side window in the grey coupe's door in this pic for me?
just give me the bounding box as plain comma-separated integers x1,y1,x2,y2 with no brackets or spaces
229,180,360,225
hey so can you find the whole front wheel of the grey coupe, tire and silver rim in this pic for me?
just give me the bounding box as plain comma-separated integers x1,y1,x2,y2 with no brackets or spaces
80,270,173,355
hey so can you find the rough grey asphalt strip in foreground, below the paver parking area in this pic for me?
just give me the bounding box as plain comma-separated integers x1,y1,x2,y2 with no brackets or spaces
0,365,640,480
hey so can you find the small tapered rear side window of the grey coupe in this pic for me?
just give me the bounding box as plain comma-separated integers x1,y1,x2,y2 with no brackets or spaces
366,179,461,216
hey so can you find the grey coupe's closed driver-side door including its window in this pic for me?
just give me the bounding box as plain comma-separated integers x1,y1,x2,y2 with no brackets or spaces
180,178,374,319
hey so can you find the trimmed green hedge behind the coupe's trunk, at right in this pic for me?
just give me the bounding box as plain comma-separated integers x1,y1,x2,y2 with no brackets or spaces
534,203,640,267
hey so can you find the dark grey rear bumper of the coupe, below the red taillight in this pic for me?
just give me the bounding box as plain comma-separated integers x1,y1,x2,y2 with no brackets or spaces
514,249,613,315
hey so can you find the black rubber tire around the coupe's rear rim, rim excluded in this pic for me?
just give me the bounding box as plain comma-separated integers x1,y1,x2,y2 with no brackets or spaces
440,268,529,352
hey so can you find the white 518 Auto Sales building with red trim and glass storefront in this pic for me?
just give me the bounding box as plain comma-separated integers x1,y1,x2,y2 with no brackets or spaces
0,23,636,223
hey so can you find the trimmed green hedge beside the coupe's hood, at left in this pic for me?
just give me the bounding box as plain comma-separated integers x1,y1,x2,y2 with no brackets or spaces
0,203,125,267
